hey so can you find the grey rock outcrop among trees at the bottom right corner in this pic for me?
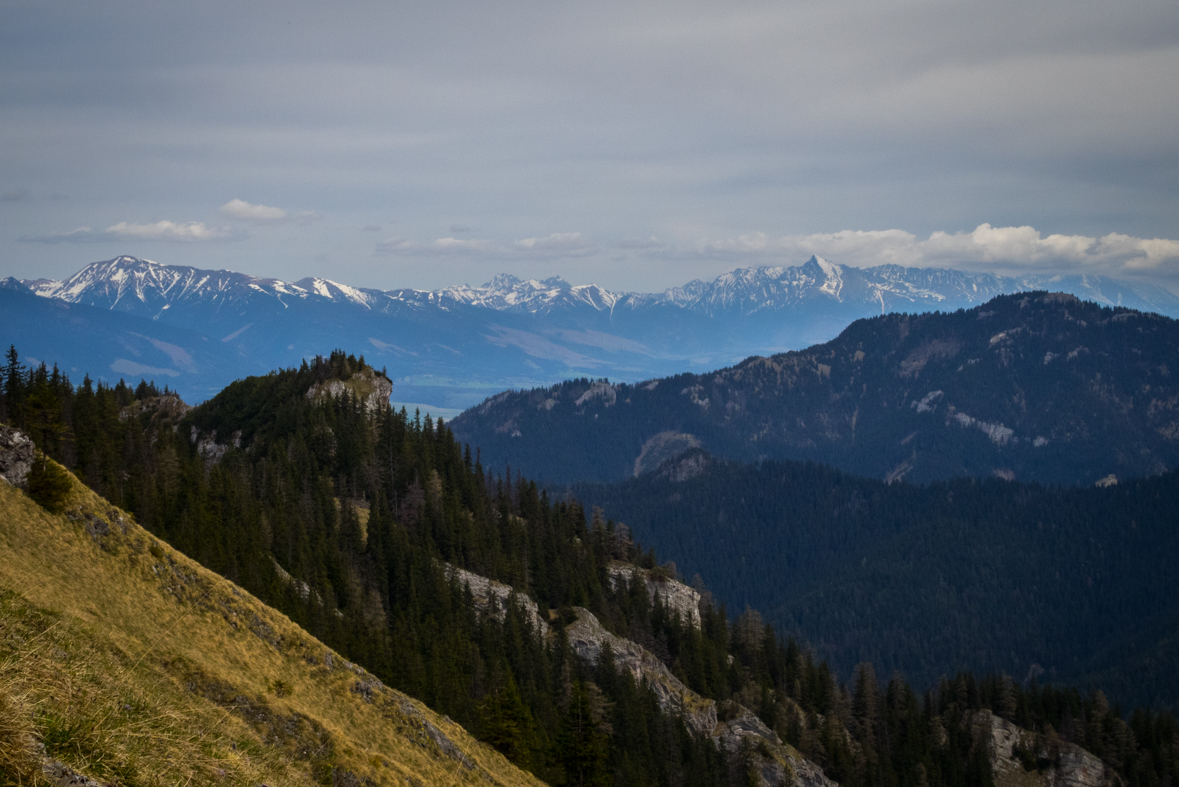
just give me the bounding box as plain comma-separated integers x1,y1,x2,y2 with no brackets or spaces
974,710,1120,787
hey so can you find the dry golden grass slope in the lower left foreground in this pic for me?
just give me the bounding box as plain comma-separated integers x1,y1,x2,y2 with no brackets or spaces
0,466,539,787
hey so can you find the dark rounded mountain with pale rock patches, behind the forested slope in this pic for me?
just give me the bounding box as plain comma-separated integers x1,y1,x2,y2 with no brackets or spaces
450,292,1179,484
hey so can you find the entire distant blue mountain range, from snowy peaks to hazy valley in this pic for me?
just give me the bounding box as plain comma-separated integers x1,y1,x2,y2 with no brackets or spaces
9,256,1179,415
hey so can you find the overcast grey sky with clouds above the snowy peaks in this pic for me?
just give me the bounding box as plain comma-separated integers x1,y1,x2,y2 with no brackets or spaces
0,0,1179,291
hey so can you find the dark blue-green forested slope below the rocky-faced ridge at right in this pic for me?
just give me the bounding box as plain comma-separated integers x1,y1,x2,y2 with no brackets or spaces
573,450,1179,708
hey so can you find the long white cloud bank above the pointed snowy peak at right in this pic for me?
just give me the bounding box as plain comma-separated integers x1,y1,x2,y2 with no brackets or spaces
652,224,1179,276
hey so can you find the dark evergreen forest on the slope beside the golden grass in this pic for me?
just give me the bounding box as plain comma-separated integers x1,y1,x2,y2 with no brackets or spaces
0,350,1179,787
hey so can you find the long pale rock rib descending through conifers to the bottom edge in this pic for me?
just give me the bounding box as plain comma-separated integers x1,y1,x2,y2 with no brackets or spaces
565,607,834,787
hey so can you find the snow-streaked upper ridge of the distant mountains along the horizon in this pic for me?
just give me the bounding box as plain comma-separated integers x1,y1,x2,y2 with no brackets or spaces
22,256,1179,317
